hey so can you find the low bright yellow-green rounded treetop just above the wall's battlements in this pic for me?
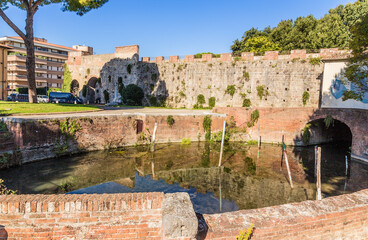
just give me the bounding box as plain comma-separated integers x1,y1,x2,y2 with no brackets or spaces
243,36,281,54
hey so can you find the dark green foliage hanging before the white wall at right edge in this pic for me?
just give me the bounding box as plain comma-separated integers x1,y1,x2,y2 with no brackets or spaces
343,14,368,101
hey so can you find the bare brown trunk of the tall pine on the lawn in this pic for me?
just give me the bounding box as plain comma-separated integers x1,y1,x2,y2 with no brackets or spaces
24,9,37,103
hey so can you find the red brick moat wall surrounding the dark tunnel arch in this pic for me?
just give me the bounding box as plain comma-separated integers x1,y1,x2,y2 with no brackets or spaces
213,107,368,159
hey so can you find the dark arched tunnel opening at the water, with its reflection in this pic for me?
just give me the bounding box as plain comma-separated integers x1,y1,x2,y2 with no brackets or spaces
293,116,355,196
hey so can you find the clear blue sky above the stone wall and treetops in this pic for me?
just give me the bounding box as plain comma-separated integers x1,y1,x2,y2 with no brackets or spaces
0,0,354,57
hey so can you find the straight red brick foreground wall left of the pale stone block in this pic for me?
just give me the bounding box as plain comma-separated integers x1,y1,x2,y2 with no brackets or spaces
0,193,164,240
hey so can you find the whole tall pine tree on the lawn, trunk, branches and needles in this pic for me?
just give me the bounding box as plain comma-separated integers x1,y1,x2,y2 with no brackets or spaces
0,0,108,103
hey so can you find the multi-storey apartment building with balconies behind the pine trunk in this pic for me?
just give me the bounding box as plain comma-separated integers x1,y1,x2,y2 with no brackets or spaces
0,37,77,93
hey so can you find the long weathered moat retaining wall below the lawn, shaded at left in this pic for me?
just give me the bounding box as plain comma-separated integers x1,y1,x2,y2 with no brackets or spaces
2,114,225,164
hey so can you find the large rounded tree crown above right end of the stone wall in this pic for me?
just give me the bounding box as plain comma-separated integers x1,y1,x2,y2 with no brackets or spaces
309,13,349,49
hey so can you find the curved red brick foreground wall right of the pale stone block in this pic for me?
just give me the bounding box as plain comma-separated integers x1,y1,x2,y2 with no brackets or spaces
204,190,368,240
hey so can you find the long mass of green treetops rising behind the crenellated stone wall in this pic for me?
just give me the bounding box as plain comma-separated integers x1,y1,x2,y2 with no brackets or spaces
231,0,368,55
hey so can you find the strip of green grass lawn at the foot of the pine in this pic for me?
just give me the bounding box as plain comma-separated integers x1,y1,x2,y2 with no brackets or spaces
0,101,99,116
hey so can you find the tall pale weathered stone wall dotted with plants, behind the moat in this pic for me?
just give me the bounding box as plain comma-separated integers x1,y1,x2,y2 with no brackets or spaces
96,59,323,108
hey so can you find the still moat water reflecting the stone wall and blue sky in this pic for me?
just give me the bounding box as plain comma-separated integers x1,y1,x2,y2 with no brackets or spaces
0,142,368,213
